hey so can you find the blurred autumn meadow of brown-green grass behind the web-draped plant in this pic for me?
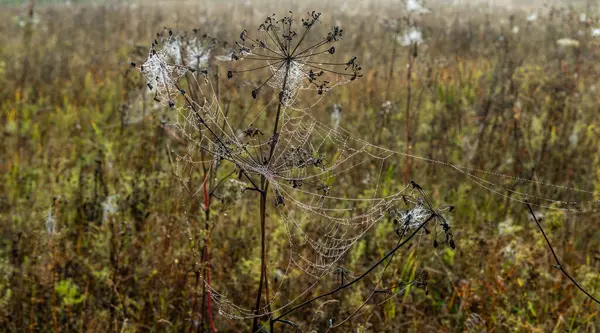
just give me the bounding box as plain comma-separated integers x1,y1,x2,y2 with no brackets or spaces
0,0,600,332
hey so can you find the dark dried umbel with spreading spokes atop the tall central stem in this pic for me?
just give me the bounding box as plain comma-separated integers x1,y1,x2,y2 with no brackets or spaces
227,11,361,105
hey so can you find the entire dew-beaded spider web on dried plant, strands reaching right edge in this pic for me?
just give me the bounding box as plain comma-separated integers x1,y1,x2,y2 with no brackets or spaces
140,27,598,319
